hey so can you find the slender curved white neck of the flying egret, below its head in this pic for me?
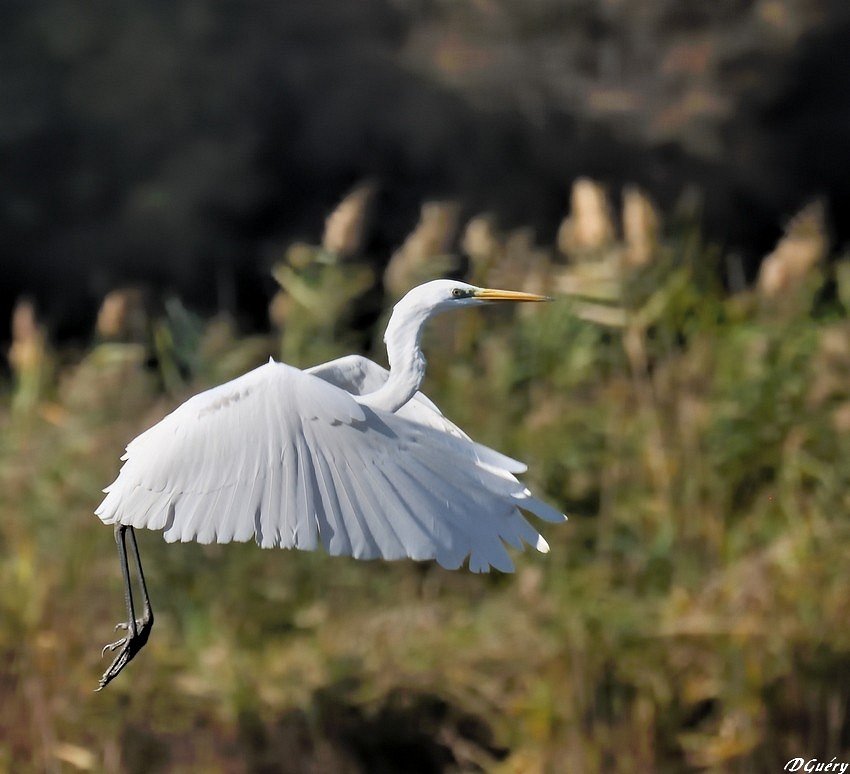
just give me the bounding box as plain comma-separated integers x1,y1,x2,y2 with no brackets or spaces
357,301,434,412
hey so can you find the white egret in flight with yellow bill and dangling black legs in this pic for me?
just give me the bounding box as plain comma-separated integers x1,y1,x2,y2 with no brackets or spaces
96,280,566,690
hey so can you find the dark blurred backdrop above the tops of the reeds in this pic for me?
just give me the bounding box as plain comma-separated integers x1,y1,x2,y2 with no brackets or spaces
0,0,850,338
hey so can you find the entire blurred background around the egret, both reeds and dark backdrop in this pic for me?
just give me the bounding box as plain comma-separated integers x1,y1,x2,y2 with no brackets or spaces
0,0,850,774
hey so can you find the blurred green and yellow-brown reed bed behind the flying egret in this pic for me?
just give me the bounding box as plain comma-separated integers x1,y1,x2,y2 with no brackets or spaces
0,183,850,772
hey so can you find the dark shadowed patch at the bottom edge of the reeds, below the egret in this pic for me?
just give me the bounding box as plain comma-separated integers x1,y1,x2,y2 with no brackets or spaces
121,683,508,774
